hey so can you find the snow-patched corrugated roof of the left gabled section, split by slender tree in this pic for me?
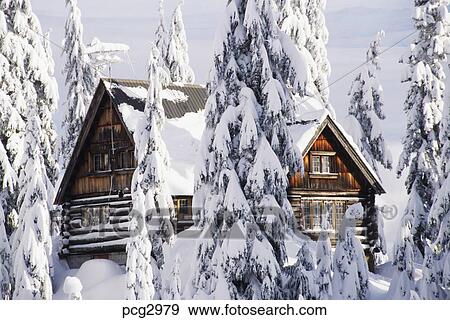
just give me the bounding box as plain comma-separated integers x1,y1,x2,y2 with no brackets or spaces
103,79,207,195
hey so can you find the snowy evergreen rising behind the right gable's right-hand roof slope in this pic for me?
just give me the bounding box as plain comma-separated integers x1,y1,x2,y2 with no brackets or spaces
347,31,392,172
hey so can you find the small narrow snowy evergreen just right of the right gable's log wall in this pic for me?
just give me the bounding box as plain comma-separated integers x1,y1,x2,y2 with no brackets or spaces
388,215,415,300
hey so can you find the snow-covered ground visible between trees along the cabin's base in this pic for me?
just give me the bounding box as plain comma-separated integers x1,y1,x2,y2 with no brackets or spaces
54,229,408,300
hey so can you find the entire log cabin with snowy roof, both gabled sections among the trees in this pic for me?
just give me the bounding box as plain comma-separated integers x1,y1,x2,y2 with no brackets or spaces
55,79,384,267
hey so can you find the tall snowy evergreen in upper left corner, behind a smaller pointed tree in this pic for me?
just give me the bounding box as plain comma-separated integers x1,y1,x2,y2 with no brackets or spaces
1,0,58,190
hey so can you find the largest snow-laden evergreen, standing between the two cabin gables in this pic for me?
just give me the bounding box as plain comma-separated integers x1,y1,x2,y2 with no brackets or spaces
192,0,310,299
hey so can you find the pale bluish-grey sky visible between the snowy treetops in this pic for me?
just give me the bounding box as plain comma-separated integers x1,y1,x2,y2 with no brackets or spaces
32,0,413,254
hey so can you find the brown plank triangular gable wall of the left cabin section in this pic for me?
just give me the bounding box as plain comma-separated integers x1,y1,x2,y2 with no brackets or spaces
67,94,136,199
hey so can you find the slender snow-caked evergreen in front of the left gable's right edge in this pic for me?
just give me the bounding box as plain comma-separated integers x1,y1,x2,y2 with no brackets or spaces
127,46,174,299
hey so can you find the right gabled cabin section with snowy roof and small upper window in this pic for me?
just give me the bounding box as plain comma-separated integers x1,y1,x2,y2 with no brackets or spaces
289,111,385,256
